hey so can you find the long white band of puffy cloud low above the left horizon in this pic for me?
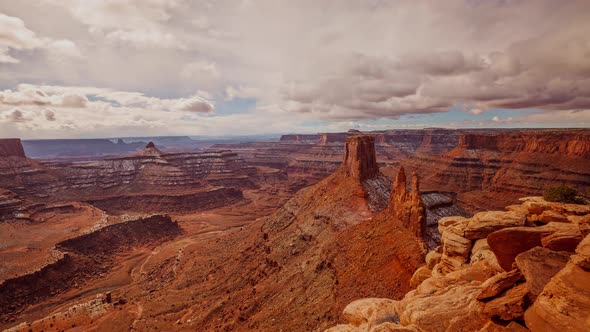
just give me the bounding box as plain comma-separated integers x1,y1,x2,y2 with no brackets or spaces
0,84,215,137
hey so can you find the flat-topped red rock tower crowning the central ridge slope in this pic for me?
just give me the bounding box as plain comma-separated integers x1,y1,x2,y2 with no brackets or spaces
341,135,379,180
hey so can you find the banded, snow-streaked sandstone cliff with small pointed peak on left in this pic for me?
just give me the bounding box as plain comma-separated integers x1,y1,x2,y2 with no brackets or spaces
0,140,257,216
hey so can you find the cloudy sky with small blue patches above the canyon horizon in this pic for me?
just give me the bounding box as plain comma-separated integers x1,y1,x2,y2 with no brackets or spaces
0,0,590,139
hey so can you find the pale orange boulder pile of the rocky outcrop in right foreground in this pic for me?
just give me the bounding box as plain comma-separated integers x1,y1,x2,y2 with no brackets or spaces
330,198,590,332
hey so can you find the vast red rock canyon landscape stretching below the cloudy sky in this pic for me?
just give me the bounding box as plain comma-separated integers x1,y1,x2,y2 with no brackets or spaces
0,128,590,331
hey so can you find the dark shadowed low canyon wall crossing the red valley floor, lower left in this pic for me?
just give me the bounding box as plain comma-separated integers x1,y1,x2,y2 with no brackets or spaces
0,215,182,323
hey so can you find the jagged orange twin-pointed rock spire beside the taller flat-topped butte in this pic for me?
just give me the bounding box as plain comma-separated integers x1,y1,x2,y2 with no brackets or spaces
386,167,426,238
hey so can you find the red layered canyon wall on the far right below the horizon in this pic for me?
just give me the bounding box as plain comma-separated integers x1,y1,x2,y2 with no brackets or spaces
412,130,590,195
